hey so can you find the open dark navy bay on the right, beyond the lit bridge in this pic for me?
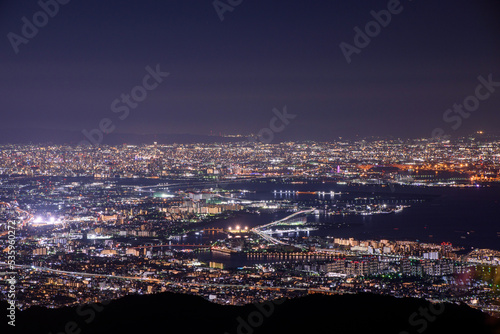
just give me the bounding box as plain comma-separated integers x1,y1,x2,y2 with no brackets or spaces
222,183,500,250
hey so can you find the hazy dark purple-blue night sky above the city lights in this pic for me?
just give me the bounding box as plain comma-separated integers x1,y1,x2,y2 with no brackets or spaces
0,0,500,140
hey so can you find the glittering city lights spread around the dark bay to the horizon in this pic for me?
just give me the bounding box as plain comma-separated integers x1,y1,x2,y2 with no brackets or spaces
0,137,500,314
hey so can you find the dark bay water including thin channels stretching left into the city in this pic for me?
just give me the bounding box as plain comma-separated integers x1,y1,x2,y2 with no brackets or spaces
8,177,500,250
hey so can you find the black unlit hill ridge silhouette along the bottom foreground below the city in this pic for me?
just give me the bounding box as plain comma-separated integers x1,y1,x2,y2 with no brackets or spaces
0,293,500,334
